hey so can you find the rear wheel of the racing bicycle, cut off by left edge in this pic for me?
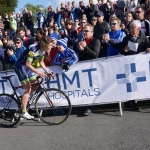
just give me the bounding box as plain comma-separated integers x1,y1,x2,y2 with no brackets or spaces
0,94,20,128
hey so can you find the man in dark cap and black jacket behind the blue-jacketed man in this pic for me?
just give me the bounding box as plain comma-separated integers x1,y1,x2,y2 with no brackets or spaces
93,11,110,58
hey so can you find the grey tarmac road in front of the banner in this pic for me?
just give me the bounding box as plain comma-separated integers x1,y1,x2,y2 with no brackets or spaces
0,108,150,150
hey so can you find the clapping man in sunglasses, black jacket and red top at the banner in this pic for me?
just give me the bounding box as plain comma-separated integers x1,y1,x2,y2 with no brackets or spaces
78,24,100,116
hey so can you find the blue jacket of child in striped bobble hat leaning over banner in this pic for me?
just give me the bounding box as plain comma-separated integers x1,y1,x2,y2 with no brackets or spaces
53,48,78,66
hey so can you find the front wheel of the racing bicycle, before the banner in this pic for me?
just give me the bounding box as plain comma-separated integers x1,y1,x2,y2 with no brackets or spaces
35,88,72,125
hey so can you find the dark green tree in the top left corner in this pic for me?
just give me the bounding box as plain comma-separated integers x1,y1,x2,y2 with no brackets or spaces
0,0,18,17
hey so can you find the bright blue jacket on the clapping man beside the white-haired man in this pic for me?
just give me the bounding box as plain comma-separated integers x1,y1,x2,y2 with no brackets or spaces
107,30,126,56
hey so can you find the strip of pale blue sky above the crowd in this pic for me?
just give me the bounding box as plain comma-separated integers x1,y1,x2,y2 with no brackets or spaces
15,0,97,13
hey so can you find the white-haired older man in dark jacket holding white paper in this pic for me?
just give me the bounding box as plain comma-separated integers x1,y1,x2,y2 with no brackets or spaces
104,20,150,111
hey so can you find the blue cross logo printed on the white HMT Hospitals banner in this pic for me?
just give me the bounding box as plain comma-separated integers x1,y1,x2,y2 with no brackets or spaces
116,63,146,92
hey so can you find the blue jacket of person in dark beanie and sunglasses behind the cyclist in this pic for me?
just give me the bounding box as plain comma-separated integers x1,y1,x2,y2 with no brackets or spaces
9,46,26,64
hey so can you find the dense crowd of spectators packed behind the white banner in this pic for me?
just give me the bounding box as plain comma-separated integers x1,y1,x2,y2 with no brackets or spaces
0,0,150,113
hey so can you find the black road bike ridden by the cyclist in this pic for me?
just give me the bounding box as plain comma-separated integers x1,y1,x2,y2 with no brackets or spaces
0,75,72,127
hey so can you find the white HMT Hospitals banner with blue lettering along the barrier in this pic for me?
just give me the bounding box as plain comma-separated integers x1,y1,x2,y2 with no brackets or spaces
0,54,150,105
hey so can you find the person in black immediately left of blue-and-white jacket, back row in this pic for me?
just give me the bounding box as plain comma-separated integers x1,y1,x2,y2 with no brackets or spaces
28,11,34,37
